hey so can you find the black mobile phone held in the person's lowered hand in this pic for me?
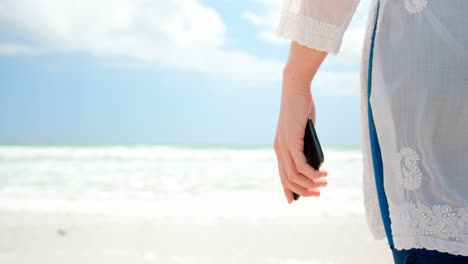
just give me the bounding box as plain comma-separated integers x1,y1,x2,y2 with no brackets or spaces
294,117,324,200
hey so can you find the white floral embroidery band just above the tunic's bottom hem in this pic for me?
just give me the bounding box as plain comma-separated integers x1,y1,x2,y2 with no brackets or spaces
394,202,468,241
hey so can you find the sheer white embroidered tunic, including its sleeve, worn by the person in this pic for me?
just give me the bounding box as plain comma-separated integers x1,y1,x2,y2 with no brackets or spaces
277,0,468,256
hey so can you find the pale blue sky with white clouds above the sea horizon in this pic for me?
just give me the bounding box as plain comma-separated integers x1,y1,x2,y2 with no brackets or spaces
0,0,368,146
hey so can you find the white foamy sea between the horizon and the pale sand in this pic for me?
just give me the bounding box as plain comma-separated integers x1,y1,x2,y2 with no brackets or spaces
0,145,364,217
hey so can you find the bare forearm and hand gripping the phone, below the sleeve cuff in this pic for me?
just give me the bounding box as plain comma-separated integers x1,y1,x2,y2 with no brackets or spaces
273,42,327,203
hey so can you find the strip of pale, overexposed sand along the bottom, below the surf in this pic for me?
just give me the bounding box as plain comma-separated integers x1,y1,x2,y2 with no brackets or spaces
0,210,392,264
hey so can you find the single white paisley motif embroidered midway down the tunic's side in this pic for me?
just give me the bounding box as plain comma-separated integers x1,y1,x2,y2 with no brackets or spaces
395,147,421,190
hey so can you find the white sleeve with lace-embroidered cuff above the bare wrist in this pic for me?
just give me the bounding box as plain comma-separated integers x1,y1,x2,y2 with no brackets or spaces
276,0,359,54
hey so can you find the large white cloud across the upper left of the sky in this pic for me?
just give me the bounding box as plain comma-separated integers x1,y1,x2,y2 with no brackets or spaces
0,0,284,84
